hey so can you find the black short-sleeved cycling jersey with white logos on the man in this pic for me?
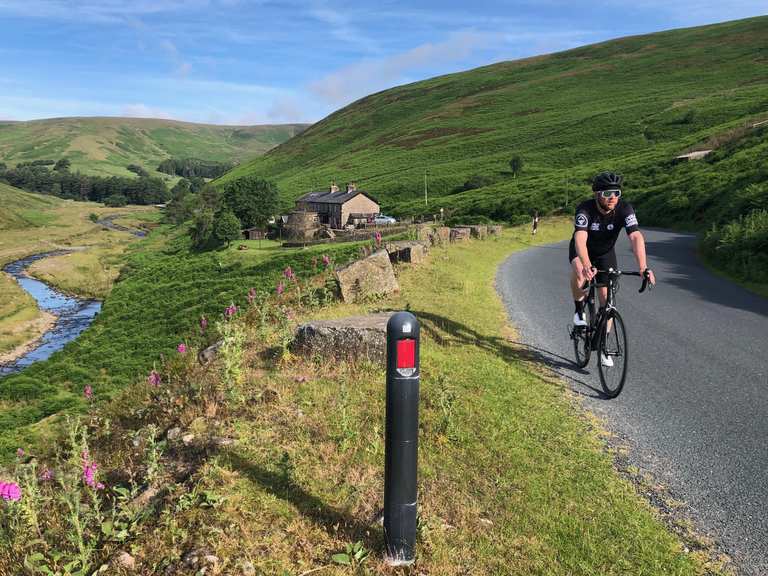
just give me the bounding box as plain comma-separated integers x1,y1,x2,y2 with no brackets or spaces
569,199,639,260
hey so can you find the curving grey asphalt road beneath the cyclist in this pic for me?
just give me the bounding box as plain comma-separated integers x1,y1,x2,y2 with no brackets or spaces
497,229,768,575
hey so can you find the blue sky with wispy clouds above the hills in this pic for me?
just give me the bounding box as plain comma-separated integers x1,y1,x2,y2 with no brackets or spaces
0,0,768,124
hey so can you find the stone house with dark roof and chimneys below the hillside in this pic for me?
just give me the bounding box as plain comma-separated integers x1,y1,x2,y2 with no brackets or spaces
296,183,381,230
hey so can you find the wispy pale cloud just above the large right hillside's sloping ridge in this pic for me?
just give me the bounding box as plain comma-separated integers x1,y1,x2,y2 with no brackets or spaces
310,31,502,105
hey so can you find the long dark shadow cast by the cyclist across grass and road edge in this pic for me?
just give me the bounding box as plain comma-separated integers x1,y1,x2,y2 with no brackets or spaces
411,310,609,400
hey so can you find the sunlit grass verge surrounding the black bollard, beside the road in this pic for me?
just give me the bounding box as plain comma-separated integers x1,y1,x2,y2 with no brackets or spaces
10,220,721,576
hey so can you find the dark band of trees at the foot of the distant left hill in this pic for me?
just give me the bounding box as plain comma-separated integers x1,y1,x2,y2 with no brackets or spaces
0,158,168,206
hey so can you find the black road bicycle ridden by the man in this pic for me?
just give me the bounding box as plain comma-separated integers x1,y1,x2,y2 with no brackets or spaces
570,268,653,398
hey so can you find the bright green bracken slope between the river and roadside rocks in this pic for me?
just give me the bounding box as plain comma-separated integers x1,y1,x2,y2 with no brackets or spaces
0,224,370,458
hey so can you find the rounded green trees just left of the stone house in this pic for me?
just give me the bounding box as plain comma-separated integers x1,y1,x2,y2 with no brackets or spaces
166,176,278,249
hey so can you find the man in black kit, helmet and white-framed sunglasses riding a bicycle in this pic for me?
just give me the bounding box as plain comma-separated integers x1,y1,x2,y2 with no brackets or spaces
568,172,656,365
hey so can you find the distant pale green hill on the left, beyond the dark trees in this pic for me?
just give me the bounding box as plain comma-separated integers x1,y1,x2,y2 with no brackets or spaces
0,118,305,176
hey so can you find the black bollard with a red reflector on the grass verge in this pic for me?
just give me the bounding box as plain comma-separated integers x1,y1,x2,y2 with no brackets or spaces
384,312,419,566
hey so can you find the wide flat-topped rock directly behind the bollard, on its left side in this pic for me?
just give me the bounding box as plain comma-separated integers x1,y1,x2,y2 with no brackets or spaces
291,312,392,364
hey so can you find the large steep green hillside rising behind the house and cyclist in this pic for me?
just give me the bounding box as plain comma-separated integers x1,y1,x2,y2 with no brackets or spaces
222,17,768,227
